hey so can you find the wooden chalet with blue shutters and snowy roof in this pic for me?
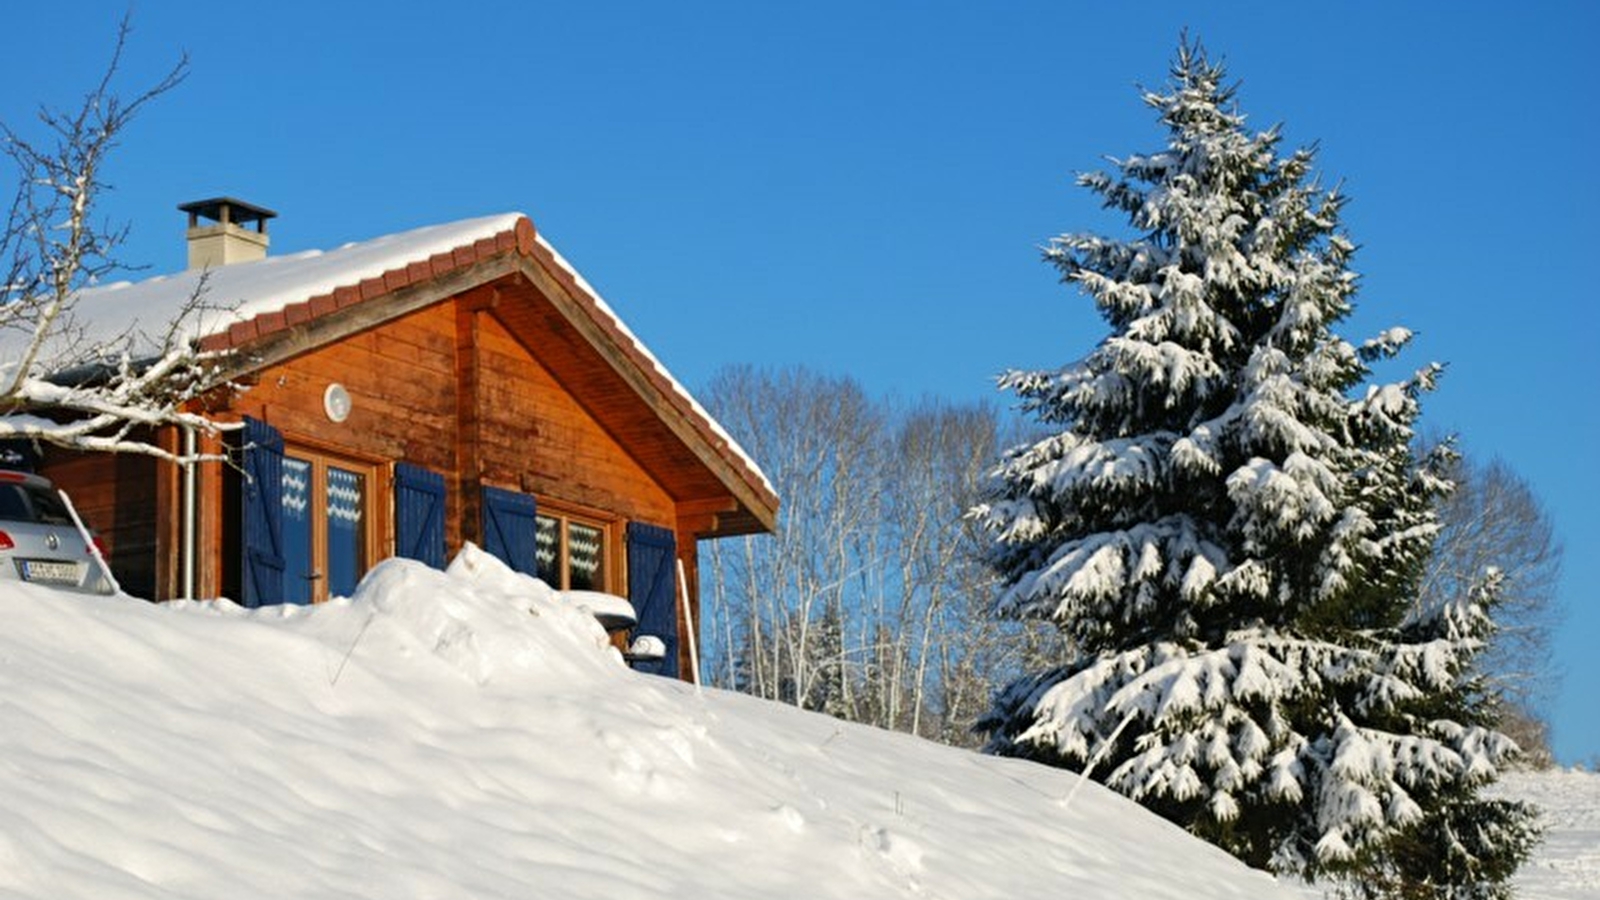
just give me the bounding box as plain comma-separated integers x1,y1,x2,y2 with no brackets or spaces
40,199,778,674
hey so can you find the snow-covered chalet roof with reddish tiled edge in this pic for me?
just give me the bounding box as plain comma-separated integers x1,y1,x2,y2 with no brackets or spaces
65,213,776,501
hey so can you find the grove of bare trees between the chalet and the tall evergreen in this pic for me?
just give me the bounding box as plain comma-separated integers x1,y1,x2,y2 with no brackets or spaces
702,367,1058,746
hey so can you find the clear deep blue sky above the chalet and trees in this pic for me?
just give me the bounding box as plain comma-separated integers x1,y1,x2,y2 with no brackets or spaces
0,0,1600,762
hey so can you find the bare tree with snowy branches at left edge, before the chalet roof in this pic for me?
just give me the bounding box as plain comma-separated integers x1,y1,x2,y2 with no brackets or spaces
0,19,230,461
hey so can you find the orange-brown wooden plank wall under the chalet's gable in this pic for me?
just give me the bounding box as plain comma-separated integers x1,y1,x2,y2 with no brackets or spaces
206,290,675,589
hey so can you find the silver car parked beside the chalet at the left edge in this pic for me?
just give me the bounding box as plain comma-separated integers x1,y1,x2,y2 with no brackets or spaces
0,469,112,594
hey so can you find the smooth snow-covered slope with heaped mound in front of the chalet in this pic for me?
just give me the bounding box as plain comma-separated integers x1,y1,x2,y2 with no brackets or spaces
0,552,1301,900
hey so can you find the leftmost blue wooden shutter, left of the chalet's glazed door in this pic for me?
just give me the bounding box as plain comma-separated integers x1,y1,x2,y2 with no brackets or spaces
238,416,283,607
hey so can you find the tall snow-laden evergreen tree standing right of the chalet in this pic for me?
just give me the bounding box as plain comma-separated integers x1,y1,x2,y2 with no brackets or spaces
973,40,1536,897
